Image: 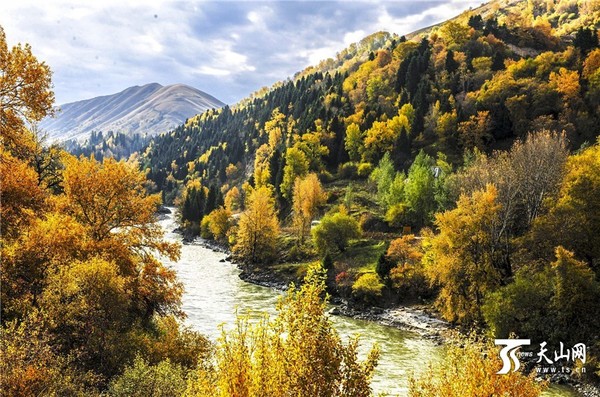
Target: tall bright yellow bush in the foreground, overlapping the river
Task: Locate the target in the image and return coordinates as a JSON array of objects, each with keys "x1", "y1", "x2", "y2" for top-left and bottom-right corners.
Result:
[{"x1": 186, "y1": 265, "x2": 379, "y2": 397}]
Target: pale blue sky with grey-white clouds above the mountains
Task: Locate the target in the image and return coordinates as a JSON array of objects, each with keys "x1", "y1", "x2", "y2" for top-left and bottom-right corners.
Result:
[{"x1": 0, "y1": 0, "x2": 481, "y2": 104}]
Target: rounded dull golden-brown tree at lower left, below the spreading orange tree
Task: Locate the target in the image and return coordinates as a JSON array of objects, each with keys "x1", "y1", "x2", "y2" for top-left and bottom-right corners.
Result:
[{"x1": 40, "y1": 258, "x2": 131, "y2": 375}]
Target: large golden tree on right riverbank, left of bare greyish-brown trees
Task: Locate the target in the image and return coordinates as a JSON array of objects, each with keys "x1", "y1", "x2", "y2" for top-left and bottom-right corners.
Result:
[{"x1": 424, "y1": 185, "x2": 502, "y2": 324}]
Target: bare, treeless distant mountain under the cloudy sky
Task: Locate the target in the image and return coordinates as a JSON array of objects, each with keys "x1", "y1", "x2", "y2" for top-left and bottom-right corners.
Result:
[{"x1": 39, "y1": 83, "x2": 224, "y2": 141}]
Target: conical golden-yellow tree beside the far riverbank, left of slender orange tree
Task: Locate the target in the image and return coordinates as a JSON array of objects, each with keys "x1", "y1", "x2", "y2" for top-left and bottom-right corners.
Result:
[{"x1": 233, "y1": 186, "x2": 279, "y2": 263}]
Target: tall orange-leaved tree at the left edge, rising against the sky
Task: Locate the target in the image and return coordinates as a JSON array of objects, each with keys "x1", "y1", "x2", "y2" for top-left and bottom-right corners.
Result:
[{"x1": 0, "y1": 26, "x2": 54, "y2": 240}]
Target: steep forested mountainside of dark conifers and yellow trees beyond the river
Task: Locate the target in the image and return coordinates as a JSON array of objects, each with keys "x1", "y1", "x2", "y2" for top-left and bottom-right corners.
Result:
[{"x1": 142, "y1": 0, "x2": 600, "y2": 212}]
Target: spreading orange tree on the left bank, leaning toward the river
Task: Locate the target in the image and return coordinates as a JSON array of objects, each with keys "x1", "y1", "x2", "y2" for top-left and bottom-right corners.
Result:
[{"x1": 59, "y1": 153, "x2": 181, "y2": 316}]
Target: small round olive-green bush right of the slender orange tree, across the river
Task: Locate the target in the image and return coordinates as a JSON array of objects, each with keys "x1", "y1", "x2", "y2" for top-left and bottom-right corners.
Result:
[{"x1": 312, "y1": 212, "x2": 361, "y2": 255}]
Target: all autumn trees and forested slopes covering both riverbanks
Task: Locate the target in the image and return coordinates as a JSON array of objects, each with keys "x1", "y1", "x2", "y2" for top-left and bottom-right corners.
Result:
[{"x1": 0, "y1": 1, "x2": 600, "y2": 396}]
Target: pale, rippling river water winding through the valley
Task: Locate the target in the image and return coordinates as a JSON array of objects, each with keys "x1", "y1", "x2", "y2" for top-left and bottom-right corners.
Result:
[{"x1": 160, "y1": 209, "x2": 576, "y2": 397}]
